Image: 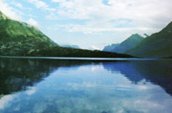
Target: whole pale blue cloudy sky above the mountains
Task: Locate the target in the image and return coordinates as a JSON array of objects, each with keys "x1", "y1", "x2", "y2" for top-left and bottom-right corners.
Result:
[{"x1": 0, "y1": 0, "x2": 172, "y2": 49}]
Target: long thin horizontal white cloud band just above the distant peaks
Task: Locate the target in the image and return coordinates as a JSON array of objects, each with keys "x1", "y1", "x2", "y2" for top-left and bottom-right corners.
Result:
[{"x1": 56, "y1": 23, "x2": 159, "y2": 35}]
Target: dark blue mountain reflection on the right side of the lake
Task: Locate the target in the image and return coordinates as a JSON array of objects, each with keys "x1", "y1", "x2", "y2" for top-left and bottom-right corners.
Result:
[{"x1": 103, "y1": 60, "x2": 172, "y2": 95}]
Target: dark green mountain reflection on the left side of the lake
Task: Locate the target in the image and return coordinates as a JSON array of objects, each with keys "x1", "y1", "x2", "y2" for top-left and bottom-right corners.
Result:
[{"x1": 0, "y1": 58, "x2": 90, "y2": 94}]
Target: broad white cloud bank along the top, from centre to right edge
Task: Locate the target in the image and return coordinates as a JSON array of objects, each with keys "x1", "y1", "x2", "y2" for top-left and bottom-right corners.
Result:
[{"x1": 53, "y1": 0, "x2": 172, "y2": 19}]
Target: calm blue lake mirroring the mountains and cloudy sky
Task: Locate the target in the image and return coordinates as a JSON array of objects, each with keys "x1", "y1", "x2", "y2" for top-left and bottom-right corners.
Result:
[{"x1": 0, "y1": 58, "x2": 172, "y2": 113}]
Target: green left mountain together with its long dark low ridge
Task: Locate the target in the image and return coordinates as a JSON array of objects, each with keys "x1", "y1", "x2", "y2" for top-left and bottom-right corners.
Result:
[{"x1": 0, "y1": 12, "x2": 130, "y2": 57}]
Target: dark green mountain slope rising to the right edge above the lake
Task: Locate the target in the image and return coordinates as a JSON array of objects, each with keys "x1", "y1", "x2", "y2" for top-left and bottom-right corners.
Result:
[{"x1": 127, "y1": 22, "x2": 172, "y2": 57}]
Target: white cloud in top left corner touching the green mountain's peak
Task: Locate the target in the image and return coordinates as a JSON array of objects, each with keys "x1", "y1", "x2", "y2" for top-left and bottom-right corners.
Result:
[{"x1": 0, "y1": 0, "x2": 21, "y2": 20}]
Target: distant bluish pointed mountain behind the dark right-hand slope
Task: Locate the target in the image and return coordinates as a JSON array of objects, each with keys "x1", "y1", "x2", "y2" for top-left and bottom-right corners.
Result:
[{"x1": 104, "y1": 34, "x2": 144, "y2": 53}]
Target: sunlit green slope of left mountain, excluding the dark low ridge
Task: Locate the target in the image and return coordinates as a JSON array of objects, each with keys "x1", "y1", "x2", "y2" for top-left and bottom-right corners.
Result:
[{"x1": 0, "y1": 12, "x2": 58, "y2": 55}]
